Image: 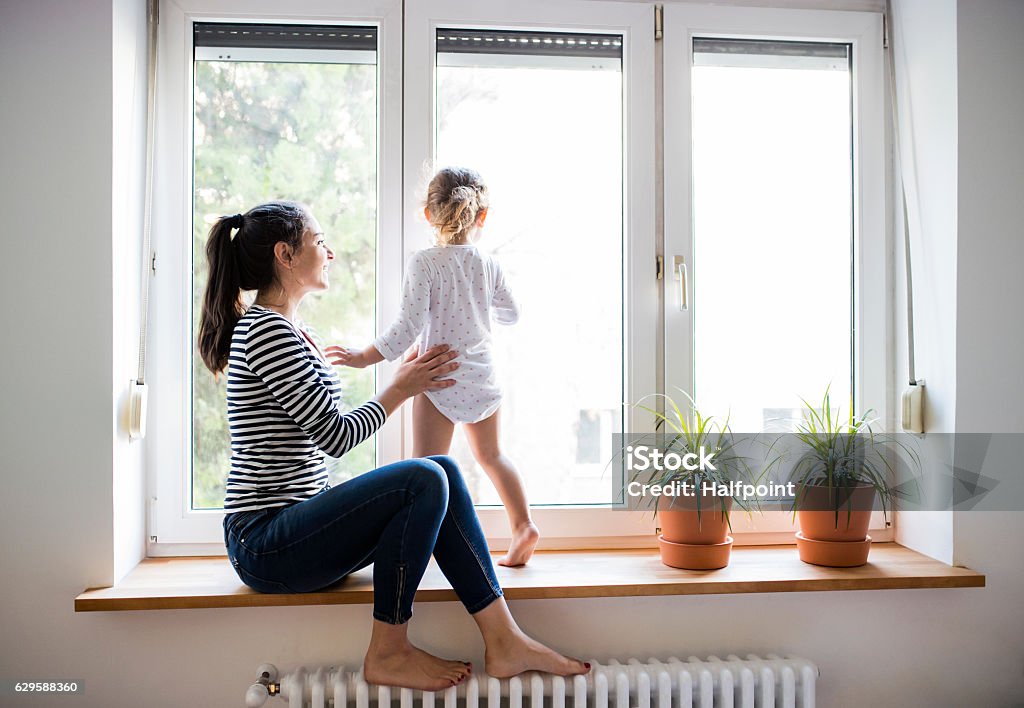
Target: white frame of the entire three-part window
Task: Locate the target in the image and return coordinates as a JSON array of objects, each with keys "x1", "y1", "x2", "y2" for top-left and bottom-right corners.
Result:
[{"x1": 145, "y1": 0, "x2": 892, "y2": 555}]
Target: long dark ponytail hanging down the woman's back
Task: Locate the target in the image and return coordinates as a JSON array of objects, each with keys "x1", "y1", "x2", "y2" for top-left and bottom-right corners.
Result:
[{"x1": 199, "y1": 214, "x2": 244, "y2": 374}]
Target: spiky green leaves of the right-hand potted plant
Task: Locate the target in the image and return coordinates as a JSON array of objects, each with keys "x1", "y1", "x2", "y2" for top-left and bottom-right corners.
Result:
[{"x1": 768, "y1": 387, "x2": 920, "y2": 523}]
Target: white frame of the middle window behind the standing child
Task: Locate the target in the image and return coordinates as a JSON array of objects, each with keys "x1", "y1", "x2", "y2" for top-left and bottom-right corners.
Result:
[{"x1": 403, "y1": 0, "x2": 658, "y2": 548}]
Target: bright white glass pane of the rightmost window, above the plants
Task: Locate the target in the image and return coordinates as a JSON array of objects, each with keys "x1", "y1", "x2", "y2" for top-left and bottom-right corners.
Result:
[{"x1": 692, "y1": 40, "x2": 853, "y2": 432}]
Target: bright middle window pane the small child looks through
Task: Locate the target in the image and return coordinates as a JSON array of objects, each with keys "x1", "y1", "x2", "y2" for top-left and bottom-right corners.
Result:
[{"x1": 434, "y1": 30, "x2": 624, "y2": 504}]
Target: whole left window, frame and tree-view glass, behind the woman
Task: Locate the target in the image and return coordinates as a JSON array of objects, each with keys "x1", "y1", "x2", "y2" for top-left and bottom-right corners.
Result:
[{"x1": 146, "y1": 0, "x2": 401, "y2": 554}]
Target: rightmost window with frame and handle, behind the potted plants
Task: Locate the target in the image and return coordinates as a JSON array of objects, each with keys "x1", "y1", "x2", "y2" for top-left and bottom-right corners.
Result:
[{"x1": 665, "y1": 6, "x2": 888, "y2": 537}]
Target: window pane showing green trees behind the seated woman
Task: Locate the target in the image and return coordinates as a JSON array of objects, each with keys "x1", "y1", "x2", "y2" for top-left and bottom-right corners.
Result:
[{"x1": 191, "y1": 43, "x2": 377, "y2": 508}]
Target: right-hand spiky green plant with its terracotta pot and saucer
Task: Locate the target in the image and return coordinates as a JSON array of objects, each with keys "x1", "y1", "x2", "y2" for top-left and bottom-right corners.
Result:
[{"x1": 769, "y1": 388, "x2": 918, "y2": 568}]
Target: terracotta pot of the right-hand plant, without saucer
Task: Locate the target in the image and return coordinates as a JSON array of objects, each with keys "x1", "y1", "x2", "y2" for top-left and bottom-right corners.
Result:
[{"x1": 797, "y1": 486, "x2": 876, "y2": 542}]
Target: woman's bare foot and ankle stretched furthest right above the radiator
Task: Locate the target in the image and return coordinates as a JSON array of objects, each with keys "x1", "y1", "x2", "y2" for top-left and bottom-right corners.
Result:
[{"x1": 472, "y1": 597, "x2": 590, "y2": 678}]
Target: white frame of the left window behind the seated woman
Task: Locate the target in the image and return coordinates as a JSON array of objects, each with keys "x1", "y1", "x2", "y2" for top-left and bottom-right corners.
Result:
[{"x1": 145, "y1": 0, "x2": 402, "y2": 556}]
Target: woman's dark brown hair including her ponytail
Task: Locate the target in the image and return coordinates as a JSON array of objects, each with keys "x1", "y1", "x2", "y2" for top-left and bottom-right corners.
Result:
[{"x1": 198, "y1": 202, "x2": 307, "y2": 374}]
